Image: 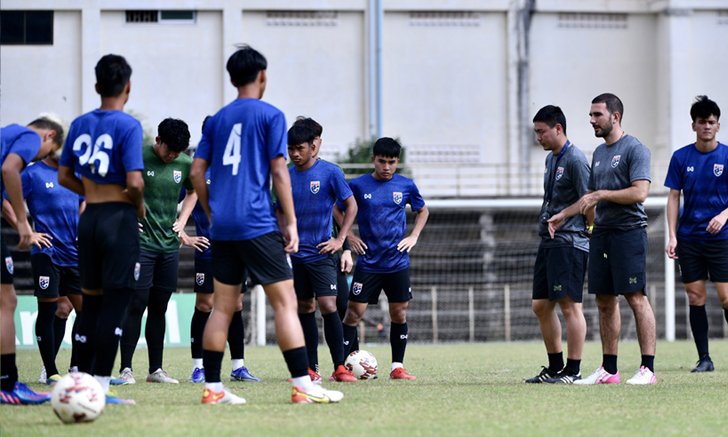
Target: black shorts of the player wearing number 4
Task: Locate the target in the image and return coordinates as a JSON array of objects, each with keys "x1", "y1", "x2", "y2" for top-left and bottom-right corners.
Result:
[{"x1": 212, "y1": 232, "x2": 293, "y2": 285}]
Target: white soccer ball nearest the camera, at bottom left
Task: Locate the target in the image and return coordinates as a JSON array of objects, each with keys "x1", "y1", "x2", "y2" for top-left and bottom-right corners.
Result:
[{"x1": 51, "y1": 372, "x2": 106, "y2": 423}]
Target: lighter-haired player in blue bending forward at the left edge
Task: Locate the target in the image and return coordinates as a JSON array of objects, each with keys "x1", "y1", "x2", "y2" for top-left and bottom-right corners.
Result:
[{"x1": 0, "y1": 119, "x2": 63, "y2": 405}]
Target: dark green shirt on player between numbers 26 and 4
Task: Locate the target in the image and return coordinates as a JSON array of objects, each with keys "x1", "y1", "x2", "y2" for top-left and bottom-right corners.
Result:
[{"x1": 139, "y1": 146, "x2": 192, "y2": 253}]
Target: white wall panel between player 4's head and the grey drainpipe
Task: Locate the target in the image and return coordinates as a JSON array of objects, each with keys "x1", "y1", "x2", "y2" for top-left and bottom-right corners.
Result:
[{"x1": 237, "y1": 11, "x2": 366, "y2": 159}]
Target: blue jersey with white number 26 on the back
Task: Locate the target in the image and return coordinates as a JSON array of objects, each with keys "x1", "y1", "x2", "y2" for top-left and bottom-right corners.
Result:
[{"x1": 61, "y1": 109, "x2": 144, "y2": 187}]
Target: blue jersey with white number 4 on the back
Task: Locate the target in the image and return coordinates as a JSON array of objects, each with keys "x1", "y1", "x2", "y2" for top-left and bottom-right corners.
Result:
[{"x1": 195, "y1": 99, "x2": 287, "y2": 241}]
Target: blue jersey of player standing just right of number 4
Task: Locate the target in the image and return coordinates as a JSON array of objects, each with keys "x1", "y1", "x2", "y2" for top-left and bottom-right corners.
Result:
[{"x1": 289, "y1": 159, "x2": 352, "y2": 263}]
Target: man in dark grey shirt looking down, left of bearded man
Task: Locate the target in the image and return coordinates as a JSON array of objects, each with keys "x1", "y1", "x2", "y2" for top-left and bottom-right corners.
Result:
[{"x1": 526, "y1": 105, "x2": 593, "y2": 384}]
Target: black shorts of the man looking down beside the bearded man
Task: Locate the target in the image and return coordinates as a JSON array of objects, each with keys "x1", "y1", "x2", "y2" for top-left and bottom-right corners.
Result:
[{"x1": 533, "y1": 246, "x2": 589, "y2": 303}]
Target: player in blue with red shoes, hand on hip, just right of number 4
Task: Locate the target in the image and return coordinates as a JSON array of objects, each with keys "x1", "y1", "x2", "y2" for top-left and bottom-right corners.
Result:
[{"x1": 288, "y1": 123, "x2": 357, "y2": 382}]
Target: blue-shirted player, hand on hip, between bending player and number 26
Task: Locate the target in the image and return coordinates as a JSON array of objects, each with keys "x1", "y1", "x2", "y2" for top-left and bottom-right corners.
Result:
[{"x1": 3, "y1": 121, "x2": 83, "y2": 384}]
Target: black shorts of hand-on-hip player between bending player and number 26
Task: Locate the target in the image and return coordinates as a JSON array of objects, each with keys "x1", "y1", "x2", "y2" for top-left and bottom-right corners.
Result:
[{"x1": 30, "y1": 253, "x2": 81, "y2": 297}]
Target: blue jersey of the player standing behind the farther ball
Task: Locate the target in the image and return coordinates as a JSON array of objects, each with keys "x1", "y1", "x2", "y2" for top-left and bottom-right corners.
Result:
[{"x1": 349, "y1": 174, "x2": 425, "y2": 273}]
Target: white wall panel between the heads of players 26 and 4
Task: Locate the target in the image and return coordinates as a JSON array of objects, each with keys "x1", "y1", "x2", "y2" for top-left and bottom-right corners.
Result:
[{"x1": 99, "y1": 11, "x2": 225, "y2": 144}]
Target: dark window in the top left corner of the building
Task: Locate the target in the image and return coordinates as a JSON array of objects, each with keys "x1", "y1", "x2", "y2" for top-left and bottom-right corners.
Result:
[{"x1": 0, "y1": 11, "x2": 53, "y2": 45}]
